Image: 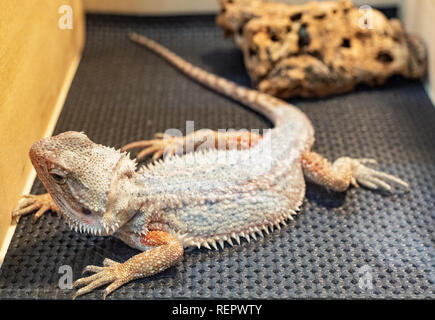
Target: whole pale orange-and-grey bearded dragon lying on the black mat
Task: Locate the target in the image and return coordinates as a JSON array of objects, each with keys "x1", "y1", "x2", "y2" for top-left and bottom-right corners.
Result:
[{"x1": 13, "y1": 34, "x2": 407, "y2": 298}]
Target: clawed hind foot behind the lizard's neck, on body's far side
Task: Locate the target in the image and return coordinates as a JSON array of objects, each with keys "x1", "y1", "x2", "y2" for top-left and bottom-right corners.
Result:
[{"x1": 121, "y1": 133, "x2": 184, "y2": 160}]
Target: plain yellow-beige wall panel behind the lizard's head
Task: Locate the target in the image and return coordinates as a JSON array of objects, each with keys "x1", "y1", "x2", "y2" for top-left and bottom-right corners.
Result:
[{"x1": 0, "y1": 0, "x2": 84, "y2": 264}]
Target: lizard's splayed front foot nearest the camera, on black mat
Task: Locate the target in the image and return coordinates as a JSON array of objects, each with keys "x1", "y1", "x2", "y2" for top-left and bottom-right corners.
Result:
[{"x1": 72, "y1": 259, "x2": 126, "y2": 299}]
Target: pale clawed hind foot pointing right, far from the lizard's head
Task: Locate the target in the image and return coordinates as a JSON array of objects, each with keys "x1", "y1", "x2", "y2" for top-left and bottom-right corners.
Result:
[{"x1": 352, "y1": 159, "x2": 409, "y2": 192}]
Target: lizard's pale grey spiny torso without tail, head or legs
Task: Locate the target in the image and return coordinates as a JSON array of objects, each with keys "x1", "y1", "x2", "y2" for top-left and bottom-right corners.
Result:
[{"x1": 137, "y1": 124, "x2": 306, "y2": 247}]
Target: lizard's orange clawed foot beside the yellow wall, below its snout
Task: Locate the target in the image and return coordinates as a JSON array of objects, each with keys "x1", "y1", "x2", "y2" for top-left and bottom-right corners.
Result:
[{"x1": 12, "y1": 193, "x2": 60, "y2": 222}]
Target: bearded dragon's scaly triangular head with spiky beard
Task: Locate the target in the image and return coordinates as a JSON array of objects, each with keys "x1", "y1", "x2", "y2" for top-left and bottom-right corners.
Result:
[{"x1": 29, "y1": 131, "x2": 136, "y2": 235}]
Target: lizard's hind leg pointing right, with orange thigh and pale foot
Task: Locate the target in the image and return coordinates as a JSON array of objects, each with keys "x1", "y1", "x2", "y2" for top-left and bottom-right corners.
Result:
[{"x1": 301, "y1": 152, "x2": 408, "y2": 192}]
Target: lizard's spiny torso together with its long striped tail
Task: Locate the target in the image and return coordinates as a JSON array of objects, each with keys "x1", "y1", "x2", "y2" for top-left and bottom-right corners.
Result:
[{"x1": 131, "y1": 34, "x2": 314, "y2": 248}]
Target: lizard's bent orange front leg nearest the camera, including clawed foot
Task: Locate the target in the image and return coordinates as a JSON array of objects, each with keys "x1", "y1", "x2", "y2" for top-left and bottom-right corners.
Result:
[{"x1": 73, "y1": 231, "x2": 183, "y2": 299}]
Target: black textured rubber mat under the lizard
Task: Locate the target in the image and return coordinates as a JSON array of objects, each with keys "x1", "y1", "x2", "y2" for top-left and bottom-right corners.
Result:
[{"x1": 0, "y1": 15, "x2": 435, "y2": 299}]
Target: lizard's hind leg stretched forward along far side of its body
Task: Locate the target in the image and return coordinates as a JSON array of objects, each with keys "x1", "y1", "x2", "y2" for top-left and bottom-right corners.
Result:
[{"x1": 121, "y1": 129, "x2": 261, "y2": 160}]
